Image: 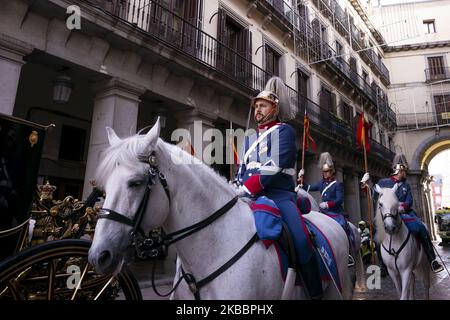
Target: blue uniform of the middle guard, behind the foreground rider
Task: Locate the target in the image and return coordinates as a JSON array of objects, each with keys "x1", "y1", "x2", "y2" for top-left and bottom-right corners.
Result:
[{"x1": 303, "y1": 177, "x2": 348, "y2": 230}]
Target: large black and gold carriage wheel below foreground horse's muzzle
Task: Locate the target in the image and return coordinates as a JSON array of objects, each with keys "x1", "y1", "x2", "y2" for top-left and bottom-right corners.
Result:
[{"x1": 0, "y1": 239, "x2": 142, "y2": 300}]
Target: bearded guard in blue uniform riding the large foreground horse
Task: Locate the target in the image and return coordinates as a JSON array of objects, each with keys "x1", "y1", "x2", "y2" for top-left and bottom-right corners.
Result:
[{"x1": 236, "y1": 77, "x2": 323, "y2": 299}]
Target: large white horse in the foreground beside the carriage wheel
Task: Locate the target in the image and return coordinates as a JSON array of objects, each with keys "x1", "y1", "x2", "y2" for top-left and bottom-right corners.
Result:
[{"x1": 89, "y1": 121, "x2": 353, "y2": 300}]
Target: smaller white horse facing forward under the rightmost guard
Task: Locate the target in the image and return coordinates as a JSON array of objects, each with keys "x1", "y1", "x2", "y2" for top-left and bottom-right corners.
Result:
[{"x1": 375, "y1": 184, "x2": 430, "y2": 300}]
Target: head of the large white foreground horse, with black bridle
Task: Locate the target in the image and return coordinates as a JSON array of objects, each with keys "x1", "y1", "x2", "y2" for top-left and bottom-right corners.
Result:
[{"x1": 89, "y1": 119, "x2": 169, "y2": 273}]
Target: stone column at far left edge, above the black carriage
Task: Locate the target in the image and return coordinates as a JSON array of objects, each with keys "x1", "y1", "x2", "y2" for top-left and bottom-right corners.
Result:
[{"x1": 0, "y1": 33, "x2": 33, "y2": 115}]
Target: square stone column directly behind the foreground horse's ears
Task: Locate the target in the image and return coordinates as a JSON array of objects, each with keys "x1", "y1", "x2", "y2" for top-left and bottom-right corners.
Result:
[{"x1": 83, "y1": 78, "x2": 145, "y2": 199}]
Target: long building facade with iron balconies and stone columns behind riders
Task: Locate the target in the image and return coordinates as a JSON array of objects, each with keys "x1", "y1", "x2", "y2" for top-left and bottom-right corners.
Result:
[{"x1": 0, "y1": 0, "x2": 396, "y2": 222}]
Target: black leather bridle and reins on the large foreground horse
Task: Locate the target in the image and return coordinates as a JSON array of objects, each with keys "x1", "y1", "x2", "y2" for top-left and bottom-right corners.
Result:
[{"x1": 98, "y1": 151, "x2": 258, "y2": 300}]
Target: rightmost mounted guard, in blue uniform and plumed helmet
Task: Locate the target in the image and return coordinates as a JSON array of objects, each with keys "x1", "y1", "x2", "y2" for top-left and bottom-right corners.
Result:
[{"x1": 361, "y1": 154, "x2": 444, "y2": 273}]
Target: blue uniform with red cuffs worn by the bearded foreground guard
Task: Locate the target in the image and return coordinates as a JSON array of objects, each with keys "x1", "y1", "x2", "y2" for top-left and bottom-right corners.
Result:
[{"x1": 236, "y1": 121, "x2": 322, "y2": 297}]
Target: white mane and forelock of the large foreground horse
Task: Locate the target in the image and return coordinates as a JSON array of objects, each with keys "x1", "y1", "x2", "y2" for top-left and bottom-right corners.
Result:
[{"x1": 95, "y1": 134, "x2": 231, "y2": 191}]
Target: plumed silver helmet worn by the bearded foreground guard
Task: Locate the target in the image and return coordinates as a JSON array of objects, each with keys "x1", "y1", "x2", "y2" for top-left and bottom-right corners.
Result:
[{"x1": 252, "y1": 77, "x2": 297, "y2": 121}]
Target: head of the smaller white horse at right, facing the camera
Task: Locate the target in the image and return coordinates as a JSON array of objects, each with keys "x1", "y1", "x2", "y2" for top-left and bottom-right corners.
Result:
[{"x1": 375, "y1": 184, "x2": 402, "y2": 235}]
